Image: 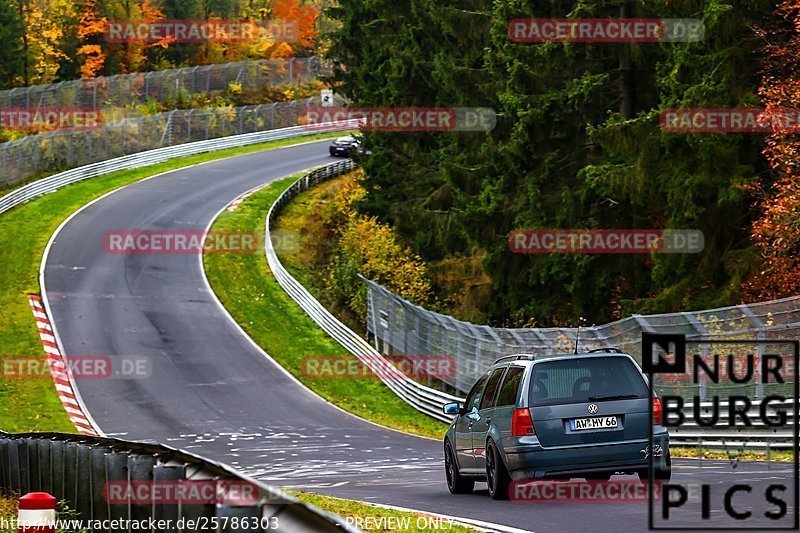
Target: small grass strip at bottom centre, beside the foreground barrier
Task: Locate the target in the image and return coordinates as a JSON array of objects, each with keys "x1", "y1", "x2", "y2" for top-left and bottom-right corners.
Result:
[{"x1": 293, "y1": 492, "x2": 482, "y2": 533}]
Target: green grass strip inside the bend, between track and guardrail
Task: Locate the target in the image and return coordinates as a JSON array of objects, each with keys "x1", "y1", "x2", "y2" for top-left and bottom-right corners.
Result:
[{"x1": 204, "y1": 175, "x2": 447, "y2": 438}]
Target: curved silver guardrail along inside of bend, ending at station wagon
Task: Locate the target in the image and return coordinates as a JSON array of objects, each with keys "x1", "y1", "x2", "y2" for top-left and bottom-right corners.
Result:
[{"x1": 264, "y1": 159, "x2": 463, "y2": 422}]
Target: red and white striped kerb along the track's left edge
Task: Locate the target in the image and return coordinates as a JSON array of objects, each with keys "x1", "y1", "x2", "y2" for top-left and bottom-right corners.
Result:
[{"x1": 28, "y1": 294, "x2": 97, "y2": 436}]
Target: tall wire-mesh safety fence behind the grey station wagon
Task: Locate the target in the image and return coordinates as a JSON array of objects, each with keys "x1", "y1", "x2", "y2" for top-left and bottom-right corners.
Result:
[{"x1": 366, "y1": 280, "x2": 800, "y2": 393}]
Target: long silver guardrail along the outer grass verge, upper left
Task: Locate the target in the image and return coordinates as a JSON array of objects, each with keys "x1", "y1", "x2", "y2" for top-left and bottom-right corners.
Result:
[{"x1": 0, "y1": 124, "x2": 349, "y2": 214}]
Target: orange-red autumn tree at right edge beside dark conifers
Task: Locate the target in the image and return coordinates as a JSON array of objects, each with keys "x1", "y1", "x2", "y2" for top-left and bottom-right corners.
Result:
[{"x1": 745, "y1": 0, "x2": 800, "y2": 300}]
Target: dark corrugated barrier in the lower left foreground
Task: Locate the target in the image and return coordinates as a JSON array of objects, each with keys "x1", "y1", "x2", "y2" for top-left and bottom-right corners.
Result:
[{"x1": 0, "y1": 432, "x2": 358, "y2": 532}]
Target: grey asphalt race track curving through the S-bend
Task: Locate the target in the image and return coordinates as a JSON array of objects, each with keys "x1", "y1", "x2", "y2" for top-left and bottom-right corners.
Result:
[{"x1": 44, "y1": 141, "x2": 792, "y2": 532}]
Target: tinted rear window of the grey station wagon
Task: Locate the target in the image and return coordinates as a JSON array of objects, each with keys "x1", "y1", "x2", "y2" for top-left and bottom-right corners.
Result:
[{"x1": 529, "y1": 356, "x2": 647, "y2": 407}]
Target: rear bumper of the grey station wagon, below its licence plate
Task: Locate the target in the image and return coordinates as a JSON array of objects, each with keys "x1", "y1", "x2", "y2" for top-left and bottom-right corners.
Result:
[{"x1": 504, "y1": 432, "x2": 669, "y2": 480}]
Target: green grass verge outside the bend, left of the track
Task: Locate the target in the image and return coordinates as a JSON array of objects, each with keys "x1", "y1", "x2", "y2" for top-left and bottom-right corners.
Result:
[{"x1": 0, "y1": 130, "x2": 339, "y2": 433}]
